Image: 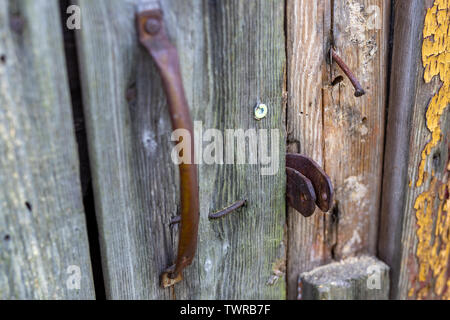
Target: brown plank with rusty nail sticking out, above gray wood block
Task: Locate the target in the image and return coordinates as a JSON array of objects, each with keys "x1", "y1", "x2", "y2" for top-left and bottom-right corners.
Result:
[{"x1": 330, "y1": 0, "x2": 390, "y2": 259}]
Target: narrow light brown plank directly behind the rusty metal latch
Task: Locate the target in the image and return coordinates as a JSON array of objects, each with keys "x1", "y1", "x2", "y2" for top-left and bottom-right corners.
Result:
[{"x1": 286, "y1": 0, "x2": 331, "y2": 299}]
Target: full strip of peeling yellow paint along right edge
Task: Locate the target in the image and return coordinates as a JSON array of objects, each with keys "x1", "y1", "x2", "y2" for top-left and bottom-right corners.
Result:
[{"x1": 408, "y1": 0, "x2": 450, "y2": 299}]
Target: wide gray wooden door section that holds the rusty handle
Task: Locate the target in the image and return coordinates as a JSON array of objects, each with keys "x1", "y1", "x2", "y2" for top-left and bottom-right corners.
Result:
[{"x1": 77, "y1": 0, "x2": 285, "y2": 299}]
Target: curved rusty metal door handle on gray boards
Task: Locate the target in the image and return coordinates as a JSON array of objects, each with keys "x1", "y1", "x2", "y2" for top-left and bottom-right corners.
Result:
[{"x1": 137, "y1": 2, "x2": 199, "y2": 288}]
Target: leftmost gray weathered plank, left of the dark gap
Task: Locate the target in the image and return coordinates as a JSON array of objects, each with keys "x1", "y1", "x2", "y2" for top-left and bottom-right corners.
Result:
[{"x1": 0, "y1": 0, "x2": 95, "y2": 299}]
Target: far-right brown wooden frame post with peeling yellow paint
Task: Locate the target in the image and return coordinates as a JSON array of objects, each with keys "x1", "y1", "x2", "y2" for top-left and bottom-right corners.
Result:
[{"x1": 379, "y1": 0, "x2": 450, "y2": 299}]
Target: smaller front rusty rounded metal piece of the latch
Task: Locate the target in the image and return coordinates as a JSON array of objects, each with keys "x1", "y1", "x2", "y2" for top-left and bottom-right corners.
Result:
[{"x1": 286, "y1": 167, "x2": 316, "y2": 217}]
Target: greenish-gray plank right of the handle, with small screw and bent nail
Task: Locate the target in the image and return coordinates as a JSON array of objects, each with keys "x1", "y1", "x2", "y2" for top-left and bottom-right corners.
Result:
[{"x1": 192, "y1": 0, "x2": 286, "y2": 299}]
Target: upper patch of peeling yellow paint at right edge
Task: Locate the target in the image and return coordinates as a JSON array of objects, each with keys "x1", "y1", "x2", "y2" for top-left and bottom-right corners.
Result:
[{"x1": 417, "y1": 0, "x2": 450, "y2": 187}]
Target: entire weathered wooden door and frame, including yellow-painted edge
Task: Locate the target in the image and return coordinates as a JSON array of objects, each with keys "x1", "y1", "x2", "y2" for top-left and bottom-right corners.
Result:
[{"x1": 0, "y1": 0, "x2": 450, "y2": 300}]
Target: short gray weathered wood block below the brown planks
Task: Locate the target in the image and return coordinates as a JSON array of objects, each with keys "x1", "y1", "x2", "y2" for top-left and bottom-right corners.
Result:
[{"x1": 299, "y1": 256, "x2": 389, "y2": 300}]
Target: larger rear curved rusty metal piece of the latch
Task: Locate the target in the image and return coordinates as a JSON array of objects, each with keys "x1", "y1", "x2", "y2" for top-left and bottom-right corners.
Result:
[{"x1": 286, "y1": 153, "x2": 333, "y2": 212}]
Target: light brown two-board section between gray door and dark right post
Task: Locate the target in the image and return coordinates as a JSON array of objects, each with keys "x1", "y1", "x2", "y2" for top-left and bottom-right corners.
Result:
[{"x1": 287, "y1": 0, "x2": 390, "y2": 299}]
